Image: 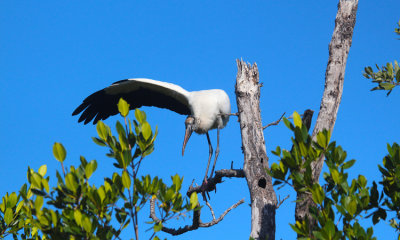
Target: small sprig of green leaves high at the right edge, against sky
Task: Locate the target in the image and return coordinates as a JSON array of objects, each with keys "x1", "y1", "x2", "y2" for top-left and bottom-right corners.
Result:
[{"x1": 363, "y1": 21, "x2": 400, "y2": 96}]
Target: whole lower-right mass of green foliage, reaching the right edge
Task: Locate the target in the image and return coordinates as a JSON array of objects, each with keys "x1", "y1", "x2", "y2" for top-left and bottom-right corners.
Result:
[{"x1": 269, "y1": 113, "x2": 400, "y2": 239}]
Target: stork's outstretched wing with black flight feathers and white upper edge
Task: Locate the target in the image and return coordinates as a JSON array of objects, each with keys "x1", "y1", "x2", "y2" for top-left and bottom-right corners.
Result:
[{"x1": 72, "y1": 78, "x2": 191, "y2": 124}]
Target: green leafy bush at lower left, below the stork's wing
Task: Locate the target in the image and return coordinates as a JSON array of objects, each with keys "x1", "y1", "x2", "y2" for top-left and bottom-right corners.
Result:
[{"x1": 0, "y1": 100, "x2": 199, "y2": 239}]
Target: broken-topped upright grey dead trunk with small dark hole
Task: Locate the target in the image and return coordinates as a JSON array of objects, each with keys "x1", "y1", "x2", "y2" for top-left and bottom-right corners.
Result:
[{"x1": 235, "y1": 60, "x2": 277, "y2": 240}]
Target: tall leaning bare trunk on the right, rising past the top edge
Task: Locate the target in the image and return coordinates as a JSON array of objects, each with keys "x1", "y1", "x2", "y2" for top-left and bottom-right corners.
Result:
[{"x1": 295, "y1": 0, "x2": 358, "y2": 230}]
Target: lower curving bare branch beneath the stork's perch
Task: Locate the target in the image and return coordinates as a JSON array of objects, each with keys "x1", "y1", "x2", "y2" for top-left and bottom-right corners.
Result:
[{"x1": 150, "y1": 198, "x2": 244, "y2": 236}]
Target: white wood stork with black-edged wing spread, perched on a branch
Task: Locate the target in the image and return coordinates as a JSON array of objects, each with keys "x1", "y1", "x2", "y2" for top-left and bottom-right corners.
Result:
[{"x1": 72, "y1": 78, "x2": 231, "y2": 184}]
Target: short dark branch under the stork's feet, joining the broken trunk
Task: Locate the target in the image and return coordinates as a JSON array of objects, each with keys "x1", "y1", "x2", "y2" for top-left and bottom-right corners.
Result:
[{"x1": 186, "y1": 169, "x2": 244, "y2": 197}]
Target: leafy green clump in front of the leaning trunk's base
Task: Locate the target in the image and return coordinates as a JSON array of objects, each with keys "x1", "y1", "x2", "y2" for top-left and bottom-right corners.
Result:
[{"x1": 269, "y1": 113, "x2": 376, "y2": 239}]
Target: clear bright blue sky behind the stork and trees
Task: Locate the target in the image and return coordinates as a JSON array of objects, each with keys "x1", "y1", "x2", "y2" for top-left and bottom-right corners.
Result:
[{"x1": 0, "y1": 0, "x2": 400, "y2": 239}]
